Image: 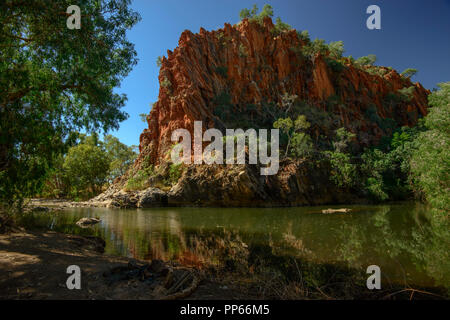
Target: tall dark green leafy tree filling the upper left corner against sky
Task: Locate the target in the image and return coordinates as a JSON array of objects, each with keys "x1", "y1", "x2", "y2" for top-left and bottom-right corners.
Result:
[{"x1": 0, "y1": 0, "x2": 140, "y2": 208}]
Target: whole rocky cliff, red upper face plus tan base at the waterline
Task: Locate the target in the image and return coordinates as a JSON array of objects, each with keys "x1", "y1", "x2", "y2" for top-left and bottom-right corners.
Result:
[{"x1": 100, "y1": 18, "x2": 429, "y2": 207}]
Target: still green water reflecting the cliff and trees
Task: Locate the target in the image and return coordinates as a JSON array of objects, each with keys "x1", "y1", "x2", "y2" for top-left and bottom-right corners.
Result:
[{"x1": 25, "y1": 203, "x2": 450, "y2": 287}]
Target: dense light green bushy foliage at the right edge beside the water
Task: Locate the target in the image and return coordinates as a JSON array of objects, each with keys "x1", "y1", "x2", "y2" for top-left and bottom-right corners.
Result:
[{"x1": 411, "y1": 82, "x2": 450, "y2": 211}]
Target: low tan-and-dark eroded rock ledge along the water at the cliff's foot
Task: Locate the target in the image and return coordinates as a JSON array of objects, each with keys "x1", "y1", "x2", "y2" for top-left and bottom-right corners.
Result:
[{"x1": 88, "y1": 160, "x2": 360, "y2": 208}]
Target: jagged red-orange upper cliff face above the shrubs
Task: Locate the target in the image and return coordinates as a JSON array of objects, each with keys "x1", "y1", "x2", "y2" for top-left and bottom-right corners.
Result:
[{"x1": 139, "y1": 18, "x2": 428, "y2": 168}]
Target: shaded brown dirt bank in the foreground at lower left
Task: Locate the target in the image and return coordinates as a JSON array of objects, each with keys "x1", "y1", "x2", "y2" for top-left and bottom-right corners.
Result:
[{"x1": 0, "y1": 231, "x2": 244, "y2": 299}]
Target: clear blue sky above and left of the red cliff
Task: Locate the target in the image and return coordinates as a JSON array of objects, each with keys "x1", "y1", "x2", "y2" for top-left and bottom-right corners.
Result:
[{"x1": 110, "y1": 0, "x2": 450, "y2": 145}]
